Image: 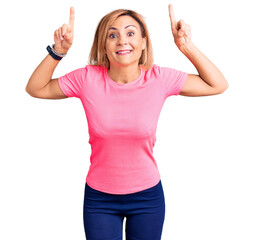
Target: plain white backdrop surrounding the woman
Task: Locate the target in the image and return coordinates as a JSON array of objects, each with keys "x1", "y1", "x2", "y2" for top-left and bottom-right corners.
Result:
[{"x1": 0, "y1": 0, "x2": 254, "y2": 240}]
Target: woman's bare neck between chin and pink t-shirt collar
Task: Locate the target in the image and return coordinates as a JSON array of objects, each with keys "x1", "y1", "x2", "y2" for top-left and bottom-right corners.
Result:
[{"x1": 108, "y1": 64, "x2": 141, "y2": 84}]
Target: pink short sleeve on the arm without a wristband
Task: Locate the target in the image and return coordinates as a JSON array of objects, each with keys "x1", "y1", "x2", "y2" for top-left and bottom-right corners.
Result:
[{"x1": 159, "y1": 67, "x2": 188, "y2": 98}]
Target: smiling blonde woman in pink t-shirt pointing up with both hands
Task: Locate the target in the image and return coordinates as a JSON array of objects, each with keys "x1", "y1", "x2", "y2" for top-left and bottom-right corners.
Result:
[{"x1": 26, "y1": 5, "x2": 228, "y2": 240}]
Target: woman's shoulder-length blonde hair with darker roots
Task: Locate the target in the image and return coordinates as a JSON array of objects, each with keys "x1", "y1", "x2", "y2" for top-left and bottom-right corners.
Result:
[{"x1": 88, "y1": 9, "x2": 153, "y2": 70}]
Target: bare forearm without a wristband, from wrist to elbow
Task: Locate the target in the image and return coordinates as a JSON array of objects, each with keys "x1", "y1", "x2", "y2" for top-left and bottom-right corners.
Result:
[{"x1": 179, "y1": 42, "x2": 228, "y2": 90}]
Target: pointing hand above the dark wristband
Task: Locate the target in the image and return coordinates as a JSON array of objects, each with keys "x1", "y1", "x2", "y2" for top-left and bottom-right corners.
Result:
[{"x1": 54, "y1": 7, "x2": 75, "y2": 54}]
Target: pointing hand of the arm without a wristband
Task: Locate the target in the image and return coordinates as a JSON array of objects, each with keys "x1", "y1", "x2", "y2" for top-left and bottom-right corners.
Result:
[{"x1": 168, "y1": 4, "x2": 191, "y2": 49}]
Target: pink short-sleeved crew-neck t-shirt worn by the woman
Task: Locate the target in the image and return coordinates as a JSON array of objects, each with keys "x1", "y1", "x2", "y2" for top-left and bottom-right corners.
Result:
[{"x1": 58, "y1": 64, "x2": 188, "y2": 194}]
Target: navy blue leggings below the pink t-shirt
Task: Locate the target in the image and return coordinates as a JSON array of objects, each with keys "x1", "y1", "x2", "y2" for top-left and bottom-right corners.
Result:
[{"x1": 83, "y1": 181, "x2": 165, "y2": 240}]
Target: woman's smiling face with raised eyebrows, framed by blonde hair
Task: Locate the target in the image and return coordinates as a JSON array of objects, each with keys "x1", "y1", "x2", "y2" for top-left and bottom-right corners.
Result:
[{"x1": 106, "y1": 16, "x2": 146, "y2": 67}]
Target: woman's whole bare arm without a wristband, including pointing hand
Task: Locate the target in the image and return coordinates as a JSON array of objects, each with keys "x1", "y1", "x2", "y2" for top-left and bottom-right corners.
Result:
[{"x1": 168, "y1": 4, "x2": 229, "y2": 96}]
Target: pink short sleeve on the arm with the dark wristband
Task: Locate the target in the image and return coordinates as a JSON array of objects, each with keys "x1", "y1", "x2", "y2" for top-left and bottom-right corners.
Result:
[{"x1": 58, "y1": 66, "x2": 87, "y2": 98}]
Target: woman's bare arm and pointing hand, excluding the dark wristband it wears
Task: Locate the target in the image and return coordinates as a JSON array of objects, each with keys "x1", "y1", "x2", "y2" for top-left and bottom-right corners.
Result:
[{"x1": 26, "y1": 7, "x2": 74, "y2": 99}]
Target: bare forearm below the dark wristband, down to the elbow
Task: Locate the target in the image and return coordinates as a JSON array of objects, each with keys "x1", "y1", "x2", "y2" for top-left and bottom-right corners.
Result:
[{"x1": 26, "y1": 54, "x2": 60, "y2": 93}]
